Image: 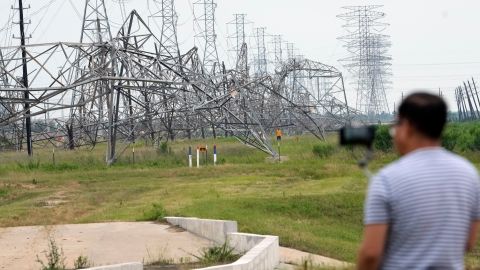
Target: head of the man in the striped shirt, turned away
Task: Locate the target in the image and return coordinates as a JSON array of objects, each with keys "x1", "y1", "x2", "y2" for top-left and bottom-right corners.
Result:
[{"x1": 394, "y1": 93, "x2": 447, "y2": 155}]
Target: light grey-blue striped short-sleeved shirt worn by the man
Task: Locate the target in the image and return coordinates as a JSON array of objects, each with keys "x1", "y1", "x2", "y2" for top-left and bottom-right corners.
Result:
[{"x1": 364, "y1": 147, "x2": 480, "y2": 269}]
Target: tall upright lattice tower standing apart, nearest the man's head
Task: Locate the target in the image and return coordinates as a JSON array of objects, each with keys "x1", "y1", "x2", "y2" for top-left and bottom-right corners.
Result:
[{"x1": 338, "y1": 6, "x2": 391, "y2": 121}]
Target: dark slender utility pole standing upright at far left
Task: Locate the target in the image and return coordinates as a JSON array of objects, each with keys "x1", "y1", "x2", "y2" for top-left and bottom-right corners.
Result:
[{"x1": 18, "y1": 0, "x2": 33, "y2": 156}]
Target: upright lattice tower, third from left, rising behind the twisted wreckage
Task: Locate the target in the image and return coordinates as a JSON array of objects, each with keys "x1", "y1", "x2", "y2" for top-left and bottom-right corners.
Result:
[{"x1": 195, "y1": 0, "x2": 219, "y2": 74}]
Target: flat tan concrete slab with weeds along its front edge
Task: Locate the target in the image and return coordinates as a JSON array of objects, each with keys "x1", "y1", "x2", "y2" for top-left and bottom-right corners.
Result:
[{"x1": 0, "y1": 222, "x2": 212, "y2": 270}]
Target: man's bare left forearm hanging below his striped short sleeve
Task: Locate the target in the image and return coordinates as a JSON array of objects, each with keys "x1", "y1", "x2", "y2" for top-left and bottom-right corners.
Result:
[{"x1": 357, "y1": 224, "x2": 388, "y2": 270}]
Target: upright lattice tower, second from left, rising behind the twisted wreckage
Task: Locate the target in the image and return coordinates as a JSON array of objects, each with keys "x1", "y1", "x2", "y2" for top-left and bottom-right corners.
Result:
[{"x1": 152, "y1": 0, "x2": 180, "y2": 59}]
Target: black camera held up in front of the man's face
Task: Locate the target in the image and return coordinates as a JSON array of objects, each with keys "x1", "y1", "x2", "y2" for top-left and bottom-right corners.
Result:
[{"x1": 340, "y1": 126, "x2": 376, "y2": 148}]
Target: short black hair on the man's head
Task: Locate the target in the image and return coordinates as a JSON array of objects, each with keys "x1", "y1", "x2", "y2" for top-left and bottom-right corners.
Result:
[{"x1": 398, "y1": 92, "x2": 447, "y2": 139}]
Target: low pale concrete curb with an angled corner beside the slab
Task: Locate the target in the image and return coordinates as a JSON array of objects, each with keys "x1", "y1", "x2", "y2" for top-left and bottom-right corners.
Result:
[{"x1": 165, "y1": 217, "x2": 280, "y2": 270}]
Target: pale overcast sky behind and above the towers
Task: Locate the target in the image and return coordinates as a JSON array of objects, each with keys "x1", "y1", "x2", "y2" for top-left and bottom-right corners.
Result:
[{"x1": 0, "y1": 0, "x2": 480, "y2": 111}]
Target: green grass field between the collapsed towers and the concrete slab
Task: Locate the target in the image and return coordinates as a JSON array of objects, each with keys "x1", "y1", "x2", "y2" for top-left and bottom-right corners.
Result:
[{"x1": 0, "y1": 136, "x2": 480, "y2": 263}]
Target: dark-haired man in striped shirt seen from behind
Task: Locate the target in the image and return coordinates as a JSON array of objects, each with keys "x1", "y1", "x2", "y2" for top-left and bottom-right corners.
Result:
[{"x1": 358, "y1": 93, "x2": 480, "y2": 269}]
